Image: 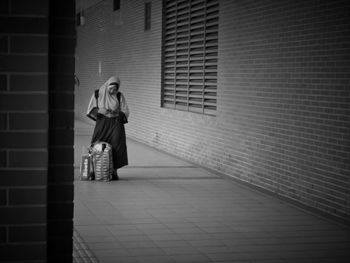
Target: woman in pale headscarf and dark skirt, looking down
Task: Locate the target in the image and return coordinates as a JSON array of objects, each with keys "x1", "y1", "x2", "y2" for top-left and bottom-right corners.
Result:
[{"x1": 87, "y1": 77, "x2": 129, "y2": 180}]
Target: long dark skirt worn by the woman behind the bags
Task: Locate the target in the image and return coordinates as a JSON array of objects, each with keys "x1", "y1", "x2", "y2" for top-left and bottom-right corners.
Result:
[{"x1": 91, "y1": 114, "x2": 128, "y2": 169}]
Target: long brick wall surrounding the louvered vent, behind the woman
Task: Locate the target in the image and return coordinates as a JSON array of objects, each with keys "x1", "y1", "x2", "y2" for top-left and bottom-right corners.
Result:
[{"x1": 75, "y1": 0, "x2": 350, "y2": 225}]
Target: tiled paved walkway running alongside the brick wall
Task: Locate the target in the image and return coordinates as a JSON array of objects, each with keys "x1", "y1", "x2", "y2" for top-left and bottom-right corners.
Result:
[{"x1": 74, "y1": 131, "x2": 350, "y2": 263}]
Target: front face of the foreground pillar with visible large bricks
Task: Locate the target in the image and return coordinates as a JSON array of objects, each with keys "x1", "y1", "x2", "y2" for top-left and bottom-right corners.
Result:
[{"x1": 0, "y1": 1, "x2": 49, "y2": 262}]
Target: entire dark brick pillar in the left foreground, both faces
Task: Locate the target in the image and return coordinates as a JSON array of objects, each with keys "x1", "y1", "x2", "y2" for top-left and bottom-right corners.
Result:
[{"x1": 0, "y1": 0, "x2": 75, "y2": 262}]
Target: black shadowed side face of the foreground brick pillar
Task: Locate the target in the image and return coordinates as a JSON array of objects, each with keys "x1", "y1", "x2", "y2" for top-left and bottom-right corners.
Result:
[{"x1": 47, "y1": 0, "x2": 76, "y2": 262}]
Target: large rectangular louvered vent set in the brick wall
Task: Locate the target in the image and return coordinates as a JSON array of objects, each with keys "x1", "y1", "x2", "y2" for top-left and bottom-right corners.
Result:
[{"x1": 162, "y1": 0, "x2": 219, "y2": 115}]
